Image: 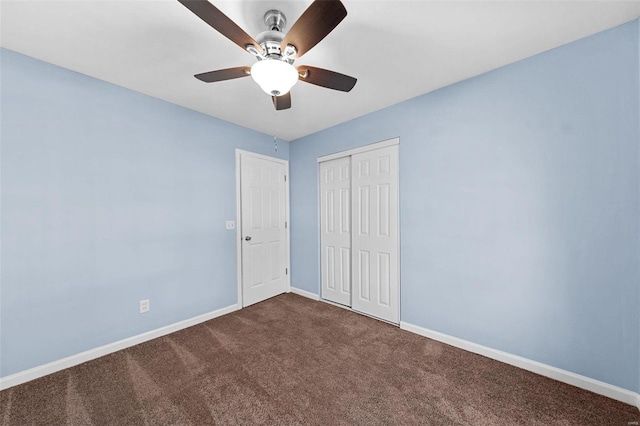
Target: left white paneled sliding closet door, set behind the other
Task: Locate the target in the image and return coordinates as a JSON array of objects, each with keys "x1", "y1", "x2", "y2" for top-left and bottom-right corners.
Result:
[{"x1": 320, "y1": 157, "x2": 351, "y2": 306}]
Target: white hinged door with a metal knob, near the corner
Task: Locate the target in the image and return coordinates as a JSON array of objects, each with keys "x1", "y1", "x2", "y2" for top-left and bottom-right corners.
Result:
[{"x1": 240, "y1": 154, "x2": 288, "y2": 306}]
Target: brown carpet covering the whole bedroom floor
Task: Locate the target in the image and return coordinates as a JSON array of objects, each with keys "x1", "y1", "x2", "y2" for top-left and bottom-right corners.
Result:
[{"x1": 0, "y1": 294, "x2": 640, "y2": 426}]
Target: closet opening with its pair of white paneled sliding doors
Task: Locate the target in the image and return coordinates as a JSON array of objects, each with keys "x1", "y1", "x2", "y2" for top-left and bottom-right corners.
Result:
[{"x1": 318, "y1": 138, "x2": 400, "y2": 324}]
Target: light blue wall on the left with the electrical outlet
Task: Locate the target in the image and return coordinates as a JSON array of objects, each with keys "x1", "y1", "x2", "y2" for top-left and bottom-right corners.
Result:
[{"x1": 0, "y1": 50, "x2": 289, "y2": 376}]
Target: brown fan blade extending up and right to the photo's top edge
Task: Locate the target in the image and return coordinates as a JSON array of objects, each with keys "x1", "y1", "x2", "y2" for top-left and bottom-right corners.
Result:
[{"x1": 280, "y1": 0, "x2": 347, "y2": 59}]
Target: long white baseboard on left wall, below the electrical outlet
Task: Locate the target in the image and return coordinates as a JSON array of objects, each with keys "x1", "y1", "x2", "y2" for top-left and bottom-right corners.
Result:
[{"x1": 0, "y1": 304, "x2": 239, "y2": 390}]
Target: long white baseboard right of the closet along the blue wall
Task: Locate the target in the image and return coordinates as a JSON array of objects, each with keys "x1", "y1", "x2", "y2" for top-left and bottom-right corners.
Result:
[{"x1": 400, "y1": 321, "x2": 640, "y2": 410}]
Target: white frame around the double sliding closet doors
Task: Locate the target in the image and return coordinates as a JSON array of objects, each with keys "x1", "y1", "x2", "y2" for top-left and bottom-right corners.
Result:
[{"x1": 316, "y1": 137, "x2": 402, "y2": 325}]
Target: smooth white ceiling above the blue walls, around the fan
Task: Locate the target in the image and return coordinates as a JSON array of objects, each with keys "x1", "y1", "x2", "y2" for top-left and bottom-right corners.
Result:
[{"x1": 0, "y1": 0, "x2": 640, "y2": 140}]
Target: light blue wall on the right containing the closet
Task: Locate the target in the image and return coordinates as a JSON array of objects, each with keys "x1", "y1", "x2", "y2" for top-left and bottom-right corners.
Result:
[{"x1": 290, "y1": 21, "x2": 640, "y2": 391}]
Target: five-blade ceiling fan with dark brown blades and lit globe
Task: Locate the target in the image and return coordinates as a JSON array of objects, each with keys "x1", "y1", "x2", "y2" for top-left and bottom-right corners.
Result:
[{"x1": 178, "y1": 0, "x2": 357, "y2": 110}]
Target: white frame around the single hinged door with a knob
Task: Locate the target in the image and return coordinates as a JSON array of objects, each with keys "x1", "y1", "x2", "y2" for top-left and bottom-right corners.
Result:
[{"x1": 236, "y1": 148, "x2": 291, "y2": 309}]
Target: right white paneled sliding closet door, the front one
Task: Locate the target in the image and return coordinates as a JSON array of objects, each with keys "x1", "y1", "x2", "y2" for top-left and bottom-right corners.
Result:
[{"x1": 351, "y1": 145, "x2": 400, "y2": 323}]
